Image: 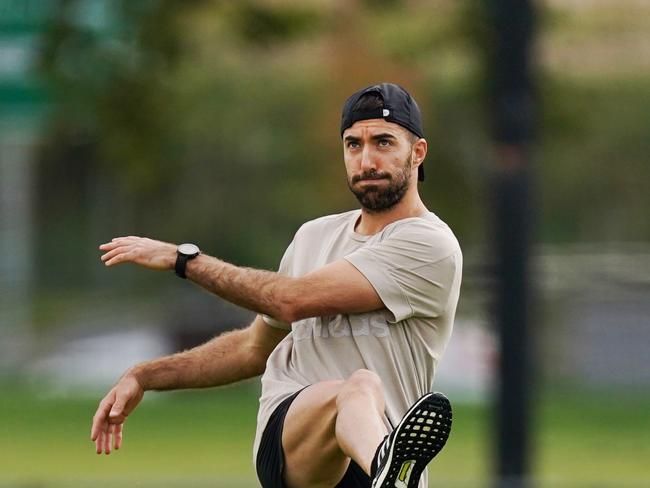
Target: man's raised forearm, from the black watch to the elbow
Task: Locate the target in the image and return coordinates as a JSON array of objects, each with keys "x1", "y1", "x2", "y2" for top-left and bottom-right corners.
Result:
[{"x1": 186, "y1": 255, "x2": 291, "y2": 322}]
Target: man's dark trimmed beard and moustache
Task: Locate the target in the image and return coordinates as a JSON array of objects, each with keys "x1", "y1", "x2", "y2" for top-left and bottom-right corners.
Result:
[{"x1": 348, "y1": 155, "x2": 411, "y2": 213}]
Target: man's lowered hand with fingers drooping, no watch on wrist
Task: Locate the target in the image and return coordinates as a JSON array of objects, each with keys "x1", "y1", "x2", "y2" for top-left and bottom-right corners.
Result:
[{"x1": 90, "y1": 373, "x2": 144, "y2": 454}]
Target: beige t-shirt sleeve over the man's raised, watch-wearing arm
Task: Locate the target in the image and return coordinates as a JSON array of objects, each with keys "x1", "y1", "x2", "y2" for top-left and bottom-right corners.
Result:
[{"x1": 345, "y1": 227, "x2": 462, "y2": 322}]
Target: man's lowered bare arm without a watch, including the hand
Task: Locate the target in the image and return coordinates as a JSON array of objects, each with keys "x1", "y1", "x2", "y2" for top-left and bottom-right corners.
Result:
[{"x1": 91, "y1": 316, "x2": 288, "y2": 454}]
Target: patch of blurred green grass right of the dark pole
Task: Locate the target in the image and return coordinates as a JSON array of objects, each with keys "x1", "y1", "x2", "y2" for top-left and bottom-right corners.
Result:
[{"x1": 537, "y1": 392, "x2": 650, "y2": 487}]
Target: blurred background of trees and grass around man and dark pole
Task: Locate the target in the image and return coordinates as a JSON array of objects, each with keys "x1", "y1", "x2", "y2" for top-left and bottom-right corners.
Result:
[{"x1": 0, "y1": 0, "x2": 650, "y2": 487}]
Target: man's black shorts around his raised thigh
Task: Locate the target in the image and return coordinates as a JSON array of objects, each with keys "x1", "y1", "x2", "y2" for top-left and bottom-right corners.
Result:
[{"x1": 256, "y1": 390, "x2": 372, "y2": 488}]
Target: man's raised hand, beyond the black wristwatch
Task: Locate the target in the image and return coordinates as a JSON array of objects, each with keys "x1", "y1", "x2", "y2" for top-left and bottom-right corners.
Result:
[{"x1": 99, "y1": 236, "x2": 177, "y2": 270}]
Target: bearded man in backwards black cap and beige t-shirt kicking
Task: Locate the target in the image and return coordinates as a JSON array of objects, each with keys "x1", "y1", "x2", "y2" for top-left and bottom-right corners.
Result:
[{"x1": 91, "y1": 83, "x2": 462, "y2": 488}]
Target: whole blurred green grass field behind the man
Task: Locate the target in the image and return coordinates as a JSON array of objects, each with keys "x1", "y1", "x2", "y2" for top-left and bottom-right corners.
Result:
[{"x1": 0, "y1": 384, "x2": 650, "y2": 488}]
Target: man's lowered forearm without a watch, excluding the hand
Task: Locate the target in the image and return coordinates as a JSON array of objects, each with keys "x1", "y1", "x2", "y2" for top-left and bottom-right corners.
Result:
[{"x1": 125, "y1": 329, "x2": 264, "y2": 390}]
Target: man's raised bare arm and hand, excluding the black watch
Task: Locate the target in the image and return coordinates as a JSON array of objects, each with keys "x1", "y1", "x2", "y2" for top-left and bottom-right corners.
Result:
[{"x1": 100, "y1": 236, "x2": 384, "y2": 324}]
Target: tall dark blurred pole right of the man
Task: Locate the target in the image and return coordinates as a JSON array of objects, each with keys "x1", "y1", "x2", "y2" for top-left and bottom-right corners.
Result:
[{"x1": 489, "y1": 0, "x2": 534, "y2": 488}]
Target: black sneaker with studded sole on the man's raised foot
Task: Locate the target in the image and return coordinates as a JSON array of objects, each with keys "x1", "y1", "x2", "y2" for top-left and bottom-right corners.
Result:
[{"x1": 372, "y1": 393, "x2": 451, "y2": 488}]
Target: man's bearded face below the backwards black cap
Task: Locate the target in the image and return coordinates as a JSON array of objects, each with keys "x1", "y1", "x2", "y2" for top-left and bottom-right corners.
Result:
[{"x1": 343, "y1": 119, "x2": 414, "y2": 213}]
